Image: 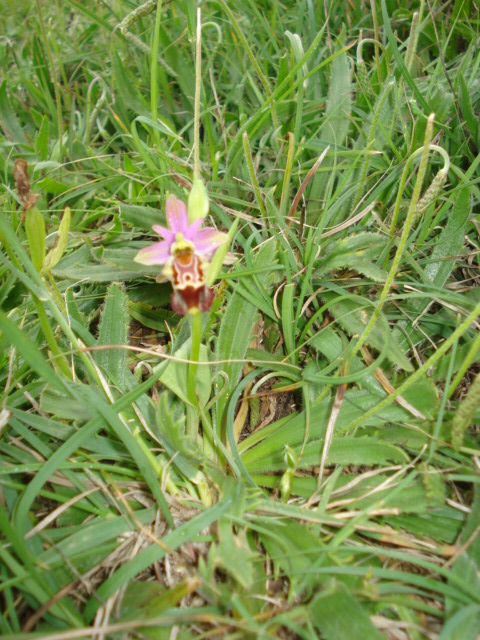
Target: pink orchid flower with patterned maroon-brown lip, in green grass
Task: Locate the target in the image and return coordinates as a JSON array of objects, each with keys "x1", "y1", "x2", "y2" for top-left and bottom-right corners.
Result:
[{"x1": 134, "y1": 195, "x2": 228, "y2": 315}]
